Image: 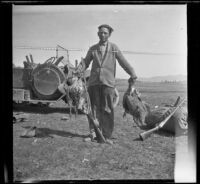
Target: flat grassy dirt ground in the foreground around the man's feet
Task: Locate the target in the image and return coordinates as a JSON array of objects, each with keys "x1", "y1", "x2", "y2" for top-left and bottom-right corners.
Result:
[{"x1": 13, "y1": 81, "x2": 187, "y2": 181}]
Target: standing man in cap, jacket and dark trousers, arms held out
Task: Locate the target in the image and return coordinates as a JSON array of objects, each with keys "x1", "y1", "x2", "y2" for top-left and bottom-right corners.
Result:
[{"x1": 77, "y1": 24, "x2": 137, "y2": 143}]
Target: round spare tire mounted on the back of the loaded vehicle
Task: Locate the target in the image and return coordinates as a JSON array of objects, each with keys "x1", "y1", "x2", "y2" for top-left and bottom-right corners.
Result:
[{"x1": 32, "y1": 63, "x2": 65, "y2": 100}]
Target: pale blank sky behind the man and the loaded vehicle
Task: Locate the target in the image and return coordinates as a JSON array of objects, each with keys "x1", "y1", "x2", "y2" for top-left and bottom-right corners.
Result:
[{"x1": 13, "y1": 5, "x2": 187, "y2": 78}]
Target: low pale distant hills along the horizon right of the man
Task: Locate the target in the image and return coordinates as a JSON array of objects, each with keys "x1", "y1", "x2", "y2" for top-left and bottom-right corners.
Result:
[{"x1": 138, "y1": 75, "x2": 187, "y2": 82}]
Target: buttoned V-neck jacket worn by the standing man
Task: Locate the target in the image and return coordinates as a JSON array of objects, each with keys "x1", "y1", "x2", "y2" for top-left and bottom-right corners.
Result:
[{"x1": 81, "y1": 42, "x2": 137, "y2": 87}]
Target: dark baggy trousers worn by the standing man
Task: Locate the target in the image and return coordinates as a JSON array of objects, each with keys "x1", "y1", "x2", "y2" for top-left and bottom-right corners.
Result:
[{"x1": 88, "y1": 85, "x2": 115, "y2": 138}]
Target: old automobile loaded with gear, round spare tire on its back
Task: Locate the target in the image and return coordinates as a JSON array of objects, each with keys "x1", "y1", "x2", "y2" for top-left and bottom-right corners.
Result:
[{"x1": 13, "y1": 46, "x2": 90, "y2": 105}]
